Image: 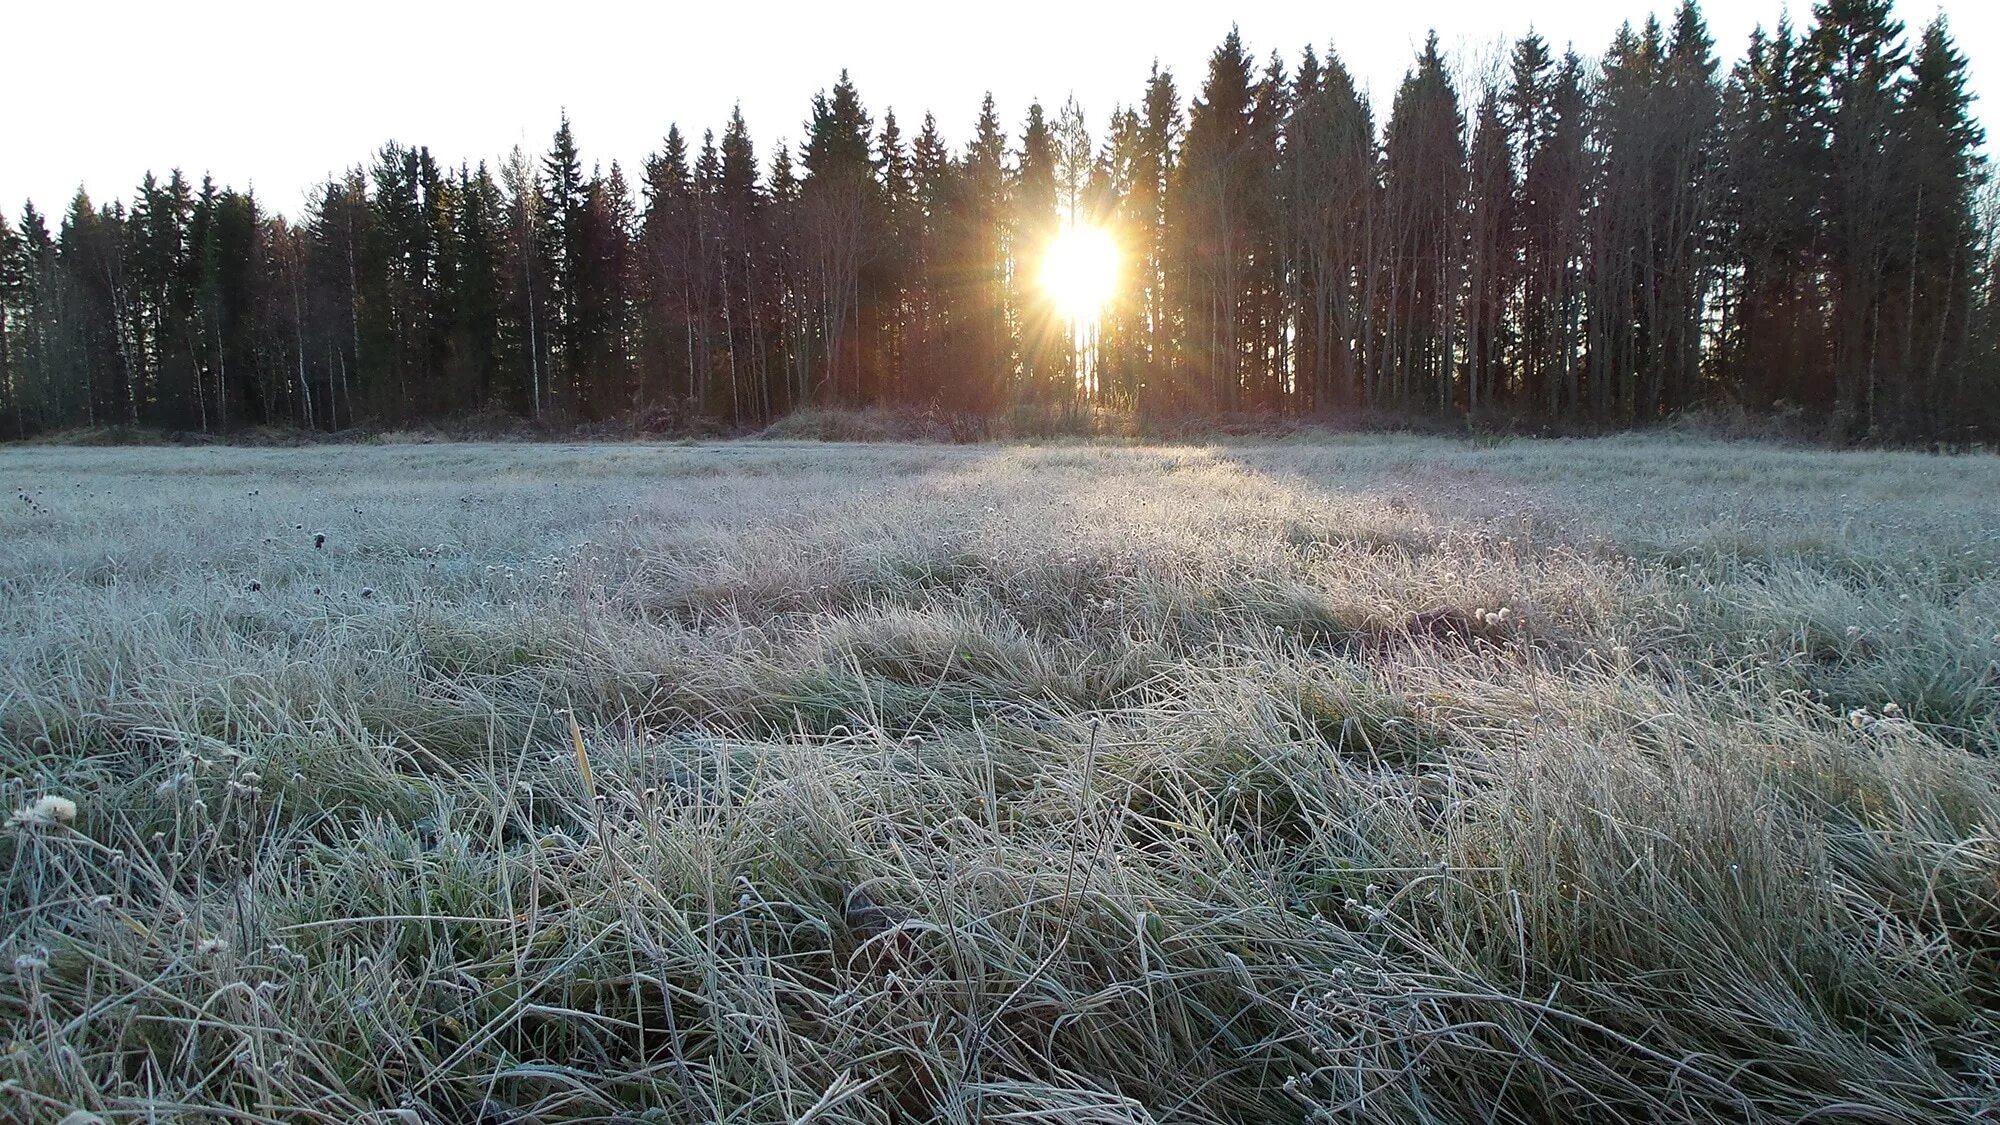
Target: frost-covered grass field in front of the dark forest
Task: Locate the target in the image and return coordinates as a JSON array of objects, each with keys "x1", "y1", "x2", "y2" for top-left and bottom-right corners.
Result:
[{"x1": 0, "y1": 436, "x2": 2000, "y2": 1125}]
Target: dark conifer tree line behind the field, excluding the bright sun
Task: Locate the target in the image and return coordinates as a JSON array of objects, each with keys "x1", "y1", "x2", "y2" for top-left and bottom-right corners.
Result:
[{"x1": 0, "y1": 0, "x2": 2000, "y2": 440}]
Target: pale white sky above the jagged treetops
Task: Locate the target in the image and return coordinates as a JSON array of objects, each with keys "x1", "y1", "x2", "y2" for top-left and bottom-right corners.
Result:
[{"x1": 0, "y1": 0, "x2": 2000, "y2": 222}]
